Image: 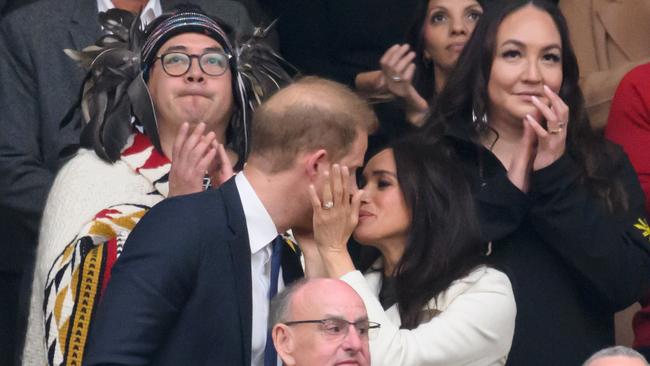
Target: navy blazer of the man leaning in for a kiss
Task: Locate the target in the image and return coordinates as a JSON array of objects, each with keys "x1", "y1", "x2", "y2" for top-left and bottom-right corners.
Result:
[{"x1": 84, "y1": 179, "x2": 252, "y2": 365}]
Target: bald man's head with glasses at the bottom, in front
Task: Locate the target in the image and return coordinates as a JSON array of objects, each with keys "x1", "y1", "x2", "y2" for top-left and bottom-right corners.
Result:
[{"x1": 269, "y1": 278, "x2": 380, "y2": 366}]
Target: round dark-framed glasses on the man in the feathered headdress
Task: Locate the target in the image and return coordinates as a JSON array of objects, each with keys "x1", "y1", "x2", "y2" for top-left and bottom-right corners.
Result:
[{"x1": 156, "y1": 52, "x2": 232, "y2": 76}]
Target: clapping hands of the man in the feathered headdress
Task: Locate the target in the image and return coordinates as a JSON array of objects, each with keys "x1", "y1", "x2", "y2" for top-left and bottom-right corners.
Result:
[{"x1": 169, "y1": 123, "x2": 233, "y2": 197}]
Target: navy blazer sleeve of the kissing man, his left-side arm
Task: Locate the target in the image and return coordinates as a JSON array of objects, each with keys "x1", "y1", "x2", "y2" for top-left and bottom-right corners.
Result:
[{"x1": 84, "y1": 197, "x2": 203, "y2": 365}]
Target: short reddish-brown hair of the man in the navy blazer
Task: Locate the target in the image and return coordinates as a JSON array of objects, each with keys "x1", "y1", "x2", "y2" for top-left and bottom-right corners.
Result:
[{"x1": 250, "y1": 77, "x2": 377, "y2": 173}]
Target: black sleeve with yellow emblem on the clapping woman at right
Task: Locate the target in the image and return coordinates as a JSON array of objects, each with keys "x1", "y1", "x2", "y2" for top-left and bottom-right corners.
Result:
[{"x1": 530, "y1": 146, "x2": 650, "y2": 311}]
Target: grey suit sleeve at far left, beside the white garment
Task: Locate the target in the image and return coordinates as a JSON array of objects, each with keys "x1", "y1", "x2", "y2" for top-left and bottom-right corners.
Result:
[{"x1": 0, "y1": 18, "x2": 54, "y2": 233}]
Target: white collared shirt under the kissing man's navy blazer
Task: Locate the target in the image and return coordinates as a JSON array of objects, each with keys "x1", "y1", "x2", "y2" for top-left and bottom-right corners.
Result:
[{"x1": 235, "y1": 172, "x2": 284, "y2": 366}]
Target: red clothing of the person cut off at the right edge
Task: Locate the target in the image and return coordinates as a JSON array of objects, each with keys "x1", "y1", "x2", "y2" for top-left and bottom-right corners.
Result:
[{"x1": 605, "y1": 64, "x2": 650, "y2": 356}]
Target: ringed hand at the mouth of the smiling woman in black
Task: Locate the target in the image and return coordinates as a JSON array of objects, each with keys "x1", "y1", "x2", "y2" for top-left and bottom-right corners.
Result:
[{"x1": 526, "y1": 85, "x2": 569, "y2": 171}]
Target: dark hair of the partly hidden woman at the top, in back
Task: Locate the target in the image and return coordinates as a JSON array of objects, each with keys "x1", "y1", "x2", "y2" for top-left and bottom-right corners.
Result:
[{"x1": 406, "y1": 0, "x2": 486, "y2": 102}]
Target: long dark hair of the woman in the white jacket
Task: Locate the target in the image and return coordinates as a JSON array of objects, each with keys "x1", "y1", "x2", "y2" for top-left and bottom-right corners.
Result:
[{"x1": 362, "y1": 136, "x2": 487, "y2": 329}]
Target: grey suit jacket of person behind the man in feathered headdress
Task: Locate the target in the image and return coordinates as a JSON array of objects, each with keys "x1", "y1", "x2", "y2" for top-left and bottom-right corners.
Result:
[{"x1": 0, "y1": 0, "x2": 252, "y2": 365}]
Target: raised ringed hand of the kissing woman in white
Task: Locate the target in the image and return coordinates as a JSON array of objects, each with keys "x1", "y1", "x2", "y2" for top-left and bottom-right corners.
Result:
[{"x1": 309, "y1": 164, "x2": 363, "y2": 255}]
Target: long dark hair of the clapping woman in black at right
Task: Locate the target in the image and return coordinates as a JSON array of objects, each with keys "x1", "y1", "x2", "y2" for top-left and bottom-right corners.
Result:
[{"x1": 424, "y1": 0, "x2": 627, "y2": 210}]
